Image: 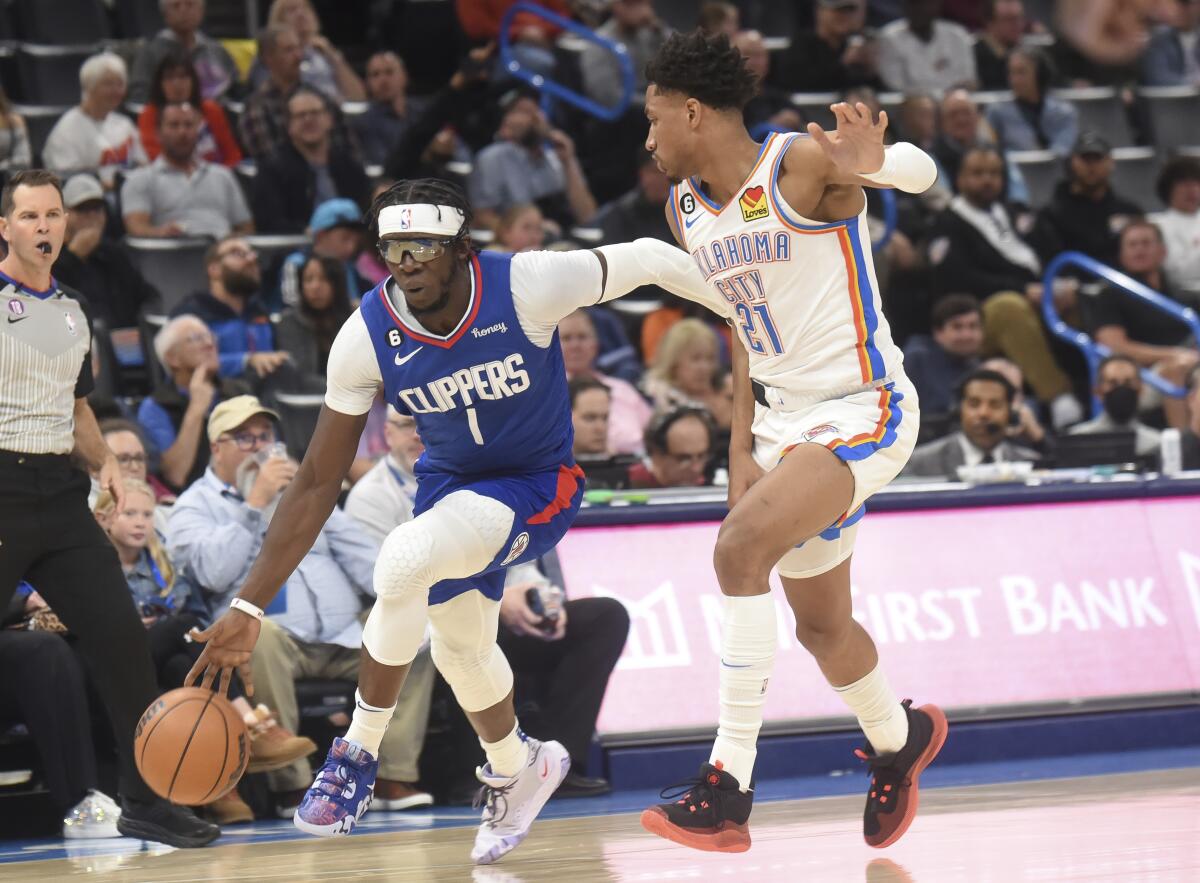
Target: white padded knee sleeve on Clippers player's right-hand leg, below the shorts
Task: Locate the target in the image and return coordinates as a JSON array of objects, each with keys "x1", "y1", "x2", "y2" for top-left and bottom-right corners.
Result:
[{"x1": 430, "y1": 591, "x2": 512, "y2": 711}]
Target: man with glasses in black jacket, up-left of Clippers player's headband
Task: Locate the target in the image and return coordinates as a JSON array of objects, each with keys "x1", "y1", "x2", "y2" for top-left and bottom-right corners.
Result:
[{"x1": 254, "y1": 86, "x2": 371, "y2": 233}]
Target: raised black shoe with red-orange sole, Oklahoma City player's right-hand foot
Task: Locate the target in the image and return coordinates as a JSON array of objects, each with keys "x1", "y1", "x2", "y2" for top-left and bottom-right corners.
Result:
[{"x1": 854, "y1": 699, "x2": 948, "y2": 848}]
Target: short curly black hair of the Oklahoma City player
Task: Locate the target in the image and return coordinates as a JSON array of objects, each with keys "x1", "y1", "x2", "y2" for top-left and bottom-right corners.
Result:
[{"x1": 646, "y1": 30, "x2": 757, "y2": 110}]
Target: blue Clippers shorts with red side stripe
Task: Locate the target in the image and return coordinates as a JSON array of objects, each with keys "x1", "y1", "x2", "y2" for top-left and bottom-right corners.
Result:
[{"x1": 413, "y1": 464, "x2": 584, "y2": 603}]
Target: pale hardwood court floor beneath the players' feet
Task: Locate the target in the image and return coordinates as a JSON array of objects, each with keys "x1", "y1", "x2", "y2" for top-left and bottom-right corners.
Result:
[{"x1": 0, "y1": 768, "x2": 1200, "y2": 883}]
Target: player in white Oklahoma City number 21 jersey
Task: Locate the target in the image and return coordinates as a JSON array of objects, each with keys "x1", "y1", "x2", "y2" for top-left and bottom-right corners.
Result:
[{"x1": 642, "y1": 32, "x2": 947, "y2": 852}]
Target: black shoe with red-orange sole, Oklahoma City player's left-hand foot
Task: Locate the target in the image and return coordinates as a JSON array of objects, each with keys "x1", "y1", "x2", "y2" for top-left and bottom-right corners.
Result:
[{"x1": 642, "y1": 763, "x2": 754, "y2": 852}]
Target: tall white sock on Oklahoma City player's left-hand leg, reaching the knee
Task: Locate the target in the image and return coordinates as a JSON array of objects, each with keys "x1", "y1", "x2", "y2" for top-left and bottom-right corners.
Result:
[{"x1": 708, "y1": 593, "x2": 779, "y2": 791}]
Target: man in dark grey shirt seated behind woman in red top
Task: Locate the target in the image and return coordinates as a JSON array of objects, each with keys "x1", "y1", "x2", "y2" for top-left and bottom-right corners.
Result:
[{"x1": 130, "y1": 0, "x2": 239, "y2": 102}]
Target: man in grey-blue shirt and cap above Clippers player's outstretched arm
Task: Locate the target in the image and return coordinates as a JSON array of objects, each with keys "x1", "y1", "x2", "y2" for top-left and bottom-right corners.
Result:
[{"x1": 470, "y1": 91, "x2": 596, "y2": 227}]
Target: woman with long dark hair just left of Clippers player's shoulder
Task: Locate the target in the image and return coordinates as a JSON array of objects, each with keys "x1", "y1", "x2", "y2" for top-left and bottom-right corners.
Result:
[{"x1": 275, "y1": 254, "x2": 354, "y2": 392}]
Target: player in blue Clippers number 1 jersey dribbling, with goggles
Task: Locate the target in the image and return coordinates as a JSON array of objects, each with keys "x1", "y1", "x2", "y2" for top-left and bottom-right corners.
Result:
[{"x1": 187, "y1": 180, "x2": 712, "y2": 864}]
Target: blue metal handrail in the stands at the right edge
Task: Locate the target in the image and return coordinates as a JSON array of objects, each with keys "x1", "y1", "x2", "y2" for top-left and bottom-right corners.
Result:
[{"x1": 1042, "y1": 252, "x2": 1200, "y2": 416}]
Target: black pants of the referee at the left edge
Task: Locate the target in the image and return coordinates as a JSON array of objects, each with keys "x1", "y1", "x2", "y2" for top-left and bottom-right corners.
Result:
[{"x1": 0, "y1": 451, "x2": 158, "y2": 800}]
